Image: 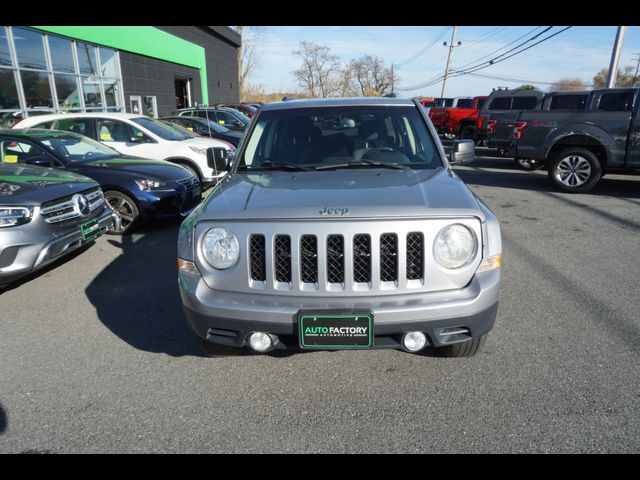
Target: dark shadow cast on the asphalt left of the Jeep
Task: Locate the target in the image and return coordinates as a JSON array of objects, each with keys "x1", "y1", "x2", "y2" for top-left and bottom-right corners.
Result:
[{"x1": 85, "y1": 221, "x2": 203, "y2": 357}]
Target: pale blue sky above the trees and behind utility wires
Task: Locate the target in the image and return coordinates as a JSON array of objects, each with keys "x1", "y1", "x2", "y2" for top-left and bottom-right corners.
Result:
[{"x1": 250, "y1": 25, "x2": 640, "y2": 97}]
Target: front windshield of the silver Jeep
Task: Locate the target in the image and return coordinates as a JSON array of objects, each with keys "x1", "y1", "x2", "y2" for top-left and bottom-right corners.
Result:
[{"x1": 237, "y1": 105, "x2": 443, "y2": 171}]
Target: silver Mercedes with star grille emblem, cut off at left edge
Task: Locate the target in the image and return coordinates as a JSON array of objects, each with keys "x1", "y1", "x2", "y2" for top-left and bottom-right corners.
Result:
[{"x1": 0, "y1": 161, "x2": 113, "y2": 288}]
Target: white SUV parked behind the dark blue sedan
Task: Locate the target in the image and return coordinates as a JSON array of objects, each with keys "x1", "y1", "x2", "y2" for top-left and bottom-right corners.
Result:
[{"x1": 12, "y1": 112, "x2": 235, "y2": 185}]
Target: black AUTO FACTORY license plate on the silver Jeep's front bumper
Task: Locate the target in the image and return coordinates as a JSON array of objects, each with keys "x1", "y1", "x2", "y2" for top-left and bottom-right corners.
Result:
[{"x1": 298, "y1": 312, "x2": 373, "y2": 349}]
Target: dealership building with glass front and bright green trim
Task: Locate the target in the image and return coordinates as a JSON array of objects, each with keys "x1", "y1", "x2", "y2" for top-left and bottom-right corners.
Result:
[{"x1": 0, "y1": 26, "x2": 241, "y2": 123}]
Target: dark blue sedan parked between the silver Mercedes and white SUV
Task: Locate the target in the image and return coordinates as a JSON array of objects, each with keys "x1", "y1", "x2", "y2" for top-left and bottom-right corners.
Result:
[{"x1": 0, "y1": 130, "x2": 202, "y2": 234}]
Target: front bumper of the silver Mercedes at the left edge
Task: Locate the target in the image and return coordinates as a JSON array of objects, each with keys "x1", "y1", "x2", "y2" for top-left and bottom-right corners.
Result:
[{"x1": 0, "y1": 208, "x2": 113, "y2": 285}]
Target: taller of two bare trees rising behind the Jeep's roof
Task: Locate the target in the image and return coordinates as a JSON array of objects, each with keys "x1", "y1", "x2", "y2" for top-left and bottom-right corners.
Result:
[{"x1": 292, "y1": 40, "x2": 341, "y2": 98}]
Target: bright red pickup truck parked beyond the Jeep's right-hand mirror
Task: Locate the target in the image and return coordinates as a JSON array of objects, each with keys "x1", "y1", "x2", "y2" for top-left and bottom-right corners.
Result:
[{"x1": 429, "y1": 96, "x2": 487, "y2": 140}]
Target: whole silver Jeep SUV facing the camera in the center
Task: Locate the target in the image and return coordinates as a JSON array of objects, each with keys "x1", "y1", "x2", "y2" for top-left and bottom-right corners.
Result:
[{"x1": 178, "y1": 98, "x2": 502, "y2": 357}]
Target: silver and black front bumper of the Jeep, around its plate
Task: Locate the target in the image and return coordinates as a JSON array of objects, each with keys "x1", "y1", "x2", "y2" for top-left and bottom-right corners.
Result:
[{"x1": 179, "y1": 269, "x2": 500, "y2": 348}]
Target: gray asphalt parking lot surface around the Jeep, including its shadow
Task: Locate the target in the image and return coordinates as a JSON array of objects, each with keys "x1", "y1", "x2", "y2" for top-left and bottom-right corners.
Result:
[{"x1": 0, "y1": 149, "x2": 640, "y2": 453}]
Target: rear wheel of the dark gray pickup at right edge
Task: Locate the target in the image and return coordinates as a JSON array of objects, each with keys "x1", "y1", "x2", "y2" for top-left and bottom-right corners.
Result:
[{"x1": 549, "y1": 147, "x2": 602, "y2": 193}]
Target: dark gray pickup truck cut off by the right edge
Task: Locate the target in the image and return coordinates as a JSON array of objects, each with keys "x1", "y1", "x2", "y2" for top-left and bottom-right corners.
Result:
[{"x1": 511, "y1": 88, "x2": 640, "y2": 193}]
